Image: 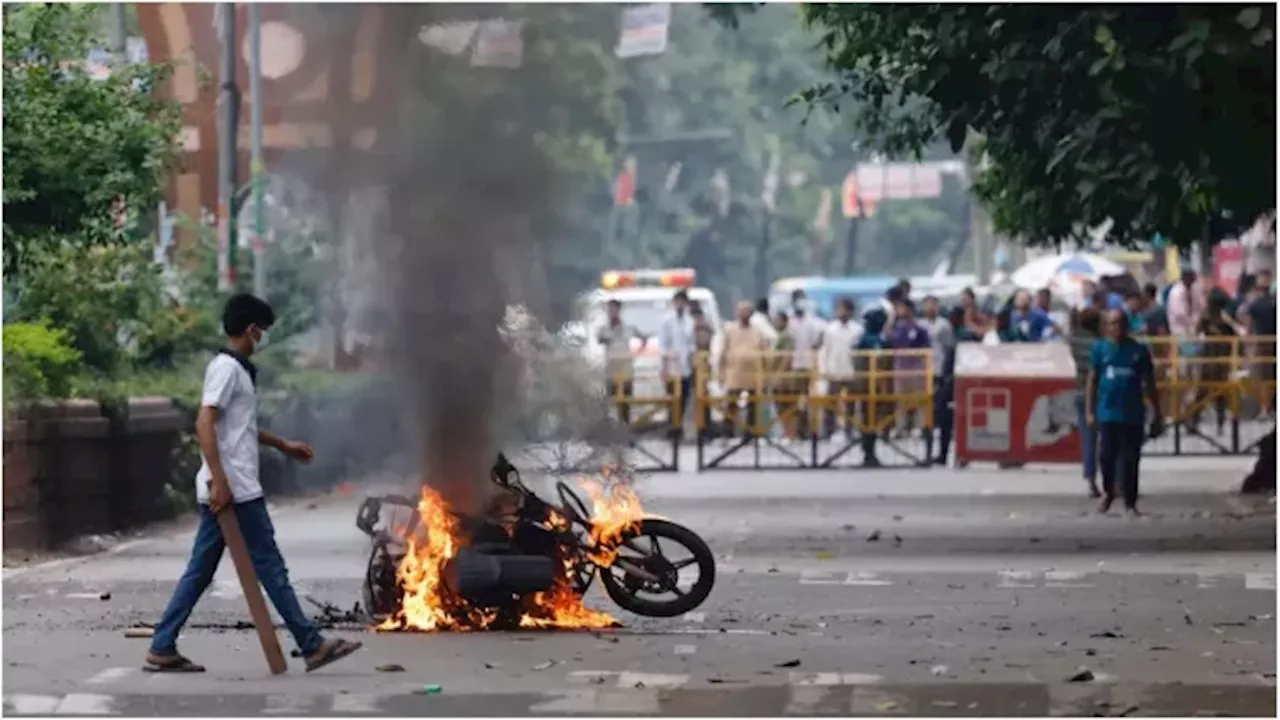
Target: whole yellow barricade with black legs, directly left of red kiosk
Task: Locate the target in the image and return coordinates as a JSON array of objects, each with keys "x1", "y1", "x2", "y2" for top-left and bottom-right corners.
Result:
[{"x1": 694, "y1": 350, "x2": 936, "y2": 470}]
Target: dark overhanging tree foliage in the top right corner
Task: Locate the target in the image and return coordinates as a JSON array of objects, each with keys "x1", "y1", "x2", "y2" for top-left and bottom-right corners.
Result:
[{"x1": 803, "y1": 4, "x2": 1276, "y2": 245}]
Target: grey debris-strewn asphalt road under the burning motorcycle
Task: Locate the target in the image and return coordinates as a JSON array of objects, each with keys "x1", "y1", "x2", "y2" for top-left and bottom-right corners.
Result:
[{"x1": 4, "y1": 460, "x2": 1276, "y2": 716}]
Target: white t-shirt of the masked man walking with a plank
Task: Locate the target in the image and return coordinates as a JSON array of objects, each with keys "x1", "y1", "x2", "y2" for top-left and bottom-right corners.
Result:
[{"x1": 196, "y1": 352, "x2": 262, "y2": 505}]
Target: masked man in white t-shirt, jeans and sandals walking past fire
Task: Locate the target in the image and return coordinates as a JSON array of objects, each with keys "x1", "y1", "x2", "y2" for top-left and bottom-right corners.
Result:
[{"x1": 145, "y1": 295, "x2": 361, "y2": 673}]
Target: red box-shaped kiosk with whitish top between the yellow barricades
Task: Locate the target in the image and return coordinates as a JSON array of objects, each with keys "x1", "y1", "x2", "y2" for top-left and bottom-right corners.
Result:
[{"x1": 955, "y1": 342, "x2": 1080, "y2": 462}]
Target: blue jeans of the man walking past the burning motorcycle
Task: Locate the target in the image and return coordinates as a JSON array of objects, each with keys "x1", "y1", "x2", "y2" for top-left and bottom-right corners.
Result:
[{"x1": 151, "y1": 498, "x2": 321, "y2": 655}]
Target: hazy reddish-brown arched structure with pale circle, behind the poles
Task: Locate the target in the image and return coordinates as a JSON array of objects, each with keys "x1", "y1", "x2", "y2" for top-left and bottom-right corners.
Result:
[{"x1": 137, "y1": 3, "x2": 403, "y2": 243}]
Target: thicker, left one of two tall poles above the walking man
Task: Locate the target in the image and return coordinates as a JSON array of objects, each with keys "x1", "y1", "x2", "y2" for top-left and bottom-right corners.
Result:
[{"x1": 218, "y1": 3, "x2": 239, "y2": 292}]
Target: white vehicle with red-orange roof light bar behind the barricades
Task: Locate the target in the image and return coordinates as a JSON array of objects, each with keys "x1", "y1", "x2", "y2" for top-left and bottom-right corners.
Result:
[{"x1": 577, "y1": 268, "x2": 724, "y2": 415}]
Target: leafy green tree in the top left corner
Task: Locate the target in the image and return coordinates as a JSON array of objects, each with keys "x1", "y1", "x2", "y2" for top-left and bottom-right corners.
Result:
[{"x1": 4, "y1": 3, "x2": 179, "y2": 279}]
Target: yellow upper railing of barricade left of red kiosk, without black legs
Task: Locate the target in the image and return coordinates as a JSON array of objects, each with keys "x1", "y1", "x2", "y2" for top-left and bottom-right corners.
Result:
[{"x1": 694, "y1": 350, "x2": 936, "y2": 437}]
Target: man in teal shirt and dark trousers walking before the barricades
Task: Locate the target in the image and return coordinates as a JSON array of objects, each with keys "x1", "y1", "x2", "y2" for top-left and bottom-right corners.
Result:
[{"x1": 1084, "y1": 304, "x2": 1164, "y2": 516}]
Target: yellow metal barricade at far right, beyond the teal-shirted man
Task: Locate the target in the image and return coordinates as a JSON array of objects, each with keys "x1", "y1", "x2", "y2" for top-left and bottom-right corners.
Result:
[{"x1": 1143, "y1": 336, "x2": 1276, "y2": 455}]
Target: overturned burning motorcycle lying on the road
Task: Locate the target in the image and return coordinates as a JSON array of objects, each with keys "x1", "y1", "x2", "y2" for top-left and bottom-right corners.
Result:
[{"x1": 356, "y1": 455, "x2": 716, "y2": 630}]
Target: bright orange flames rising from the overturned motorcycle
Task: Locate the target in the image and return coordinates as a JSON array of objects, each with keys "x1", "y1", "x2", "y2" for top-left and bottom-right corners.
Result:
[{"x1": 375, "y1": 482, "x2": 643, "y2": 632}]
